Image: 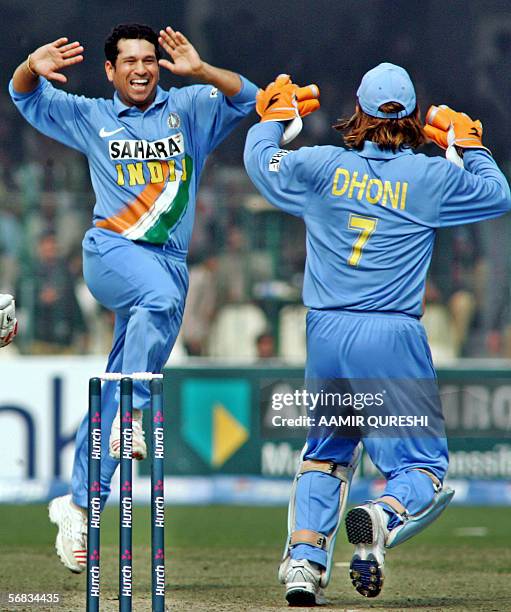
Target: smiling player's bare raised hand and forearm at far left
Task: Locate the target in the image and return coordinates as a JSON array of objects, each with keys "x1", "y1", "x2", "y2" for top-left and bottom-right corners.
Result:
[{"x1": 12, "y1": 38, "x2": 83, "y2": 93}]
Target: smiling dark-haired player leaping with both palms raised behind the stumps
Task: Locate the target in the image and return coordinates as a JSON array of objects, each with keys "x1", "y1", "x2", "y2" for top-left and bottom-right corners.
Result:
[{"x1": 9, "y1": 24, "x2": 257, "y2": 572}]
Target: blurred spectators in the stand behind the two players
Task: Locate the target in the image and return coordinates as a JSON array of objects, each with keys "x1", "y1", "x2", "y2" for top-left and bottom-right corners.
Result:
[{"x1": 0, "y1": 109, "x2": 511, "y2": 363}]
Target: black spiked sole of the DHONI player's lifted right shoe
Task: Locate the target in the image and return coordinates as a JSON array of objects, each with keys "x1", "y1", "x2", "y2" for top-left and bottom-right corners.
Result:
[{"x1": 346, "y1": 508, "x2": 384, "y2": 597}]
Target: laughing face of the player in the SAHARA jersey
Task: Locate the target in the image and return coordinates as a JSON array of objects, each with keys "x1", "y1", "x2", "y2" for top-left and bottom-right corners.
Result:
[{"x1": 105, "y1": 38, "x2": 160, "y2": 111}]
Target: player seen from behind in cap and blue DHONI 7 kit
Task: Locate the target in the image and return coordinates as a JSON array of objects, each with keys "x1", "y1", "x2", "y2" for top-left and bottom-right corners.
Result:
[{"x1": 245, "y1": 69, "x2": 511, "y2": 605}]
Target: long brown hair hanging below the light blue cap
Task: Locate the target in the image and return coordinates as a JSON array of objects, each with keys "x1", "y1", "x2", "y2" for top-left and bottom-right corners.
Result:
[{"x1": 332, "y1": 102, "x2": 427, "y2": 153}]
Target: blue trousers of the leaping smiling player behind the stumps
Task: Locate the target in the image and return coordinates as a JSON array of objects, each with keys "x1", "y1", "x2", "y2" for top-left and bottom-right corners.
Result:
[{"x1": 71, "y1": 228, "x2": 188, "y2": 507}]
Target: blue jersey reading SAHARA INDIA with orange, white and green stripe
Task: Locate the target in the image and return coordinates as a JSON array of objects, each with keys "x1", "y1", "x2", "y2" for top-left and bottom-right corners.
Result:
[{"x1": 9, "y1": 77, "x2": 257, "y2": 246}]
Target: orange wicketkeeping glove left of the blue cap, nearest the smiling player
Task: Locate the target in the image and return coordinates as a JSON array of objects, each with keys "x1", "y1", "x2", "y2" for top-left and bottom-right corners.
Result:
[{"x1": 256, "y1": 74, "x2": 320, "y2": 145}]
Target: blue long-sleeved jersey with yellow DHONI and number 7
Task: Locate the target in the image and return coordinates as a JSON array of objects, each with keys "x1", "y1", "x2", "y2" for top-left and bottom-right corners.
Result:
[{"x1": 245, "y1": 122, "x2": 511, "y2": 316}]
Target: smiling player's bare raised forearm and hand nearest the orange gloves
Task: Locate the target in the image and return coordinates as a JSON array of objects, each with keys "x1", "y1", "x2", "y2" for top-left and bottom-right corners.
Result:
[{"x1": 158, "y1": 26, "x2": 241, "y2": 96}]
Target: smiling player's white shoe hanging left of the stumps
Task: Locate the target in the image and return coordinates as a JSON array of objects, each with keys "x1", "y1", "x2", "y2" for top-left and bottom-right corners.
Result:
[{"x1": 48, "y1": 495, "x2": 87, "y2": 574}]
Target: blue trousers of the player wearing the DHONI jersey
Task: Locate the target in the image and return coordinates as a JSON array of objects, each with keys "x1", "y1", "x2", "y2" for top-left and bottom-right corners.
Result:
[{"x1": 291, "y1": 310, "x2": 448, "y2": 566}]
